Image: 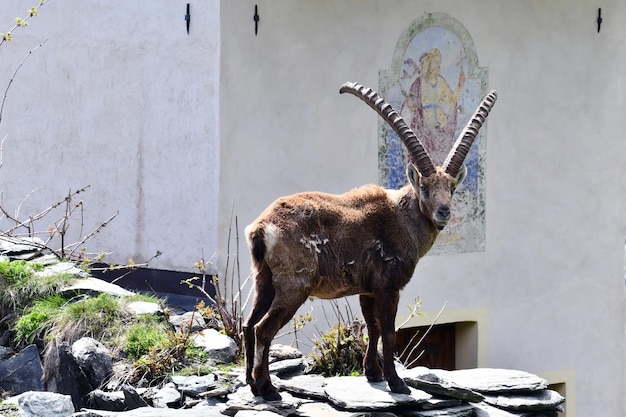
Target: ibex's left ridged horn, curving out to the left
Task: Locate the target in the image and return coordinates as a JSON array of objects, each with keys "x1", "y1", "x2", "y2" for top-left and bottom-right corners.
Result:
[{"x1": 339, "y1": 82, "x2": 435, "y2": 177}]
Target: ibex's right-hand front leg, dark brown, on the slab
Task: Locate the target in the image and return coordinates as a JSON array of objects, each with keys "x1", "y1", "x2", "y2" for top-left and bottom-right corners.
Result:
[{"x1": 374, "y1": 289, "x2": 411, "y2": 394}]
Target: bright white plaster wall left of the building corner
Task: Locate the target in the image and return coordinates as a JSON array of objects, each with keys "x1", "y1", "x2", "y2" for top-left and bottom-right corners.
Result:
[{"x1": 0, "y1": 0, "x2": 220, "y2": 271}]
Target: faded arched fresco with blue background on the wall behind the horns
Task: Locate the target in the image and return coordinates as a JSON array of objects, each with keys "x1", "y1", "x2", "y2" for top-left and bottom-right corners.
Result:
[{"x1": 378, "y1": 13, "x2": 487, "y2": 254}]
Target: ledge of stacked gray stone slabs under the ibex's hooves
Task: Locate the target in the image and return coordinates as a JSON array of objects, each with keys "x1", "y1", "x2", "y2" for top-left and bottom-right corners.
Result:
[{"x1": 2, "y1": 343, "x2": 565, "y2": 417}]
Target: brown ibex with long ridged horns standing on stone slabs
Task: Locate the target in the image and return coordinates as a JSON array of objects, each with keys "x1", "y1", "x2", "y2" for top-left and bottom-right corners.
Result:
[{"x1": 244, "y1": 83, "x2": 497, "y2": 401}]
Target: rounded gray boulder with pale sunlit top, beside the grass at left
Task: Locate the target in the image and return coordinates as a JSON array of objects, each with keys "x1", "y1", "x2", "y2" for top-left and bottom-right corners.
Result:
[{"x1": 72, "y1": 337, "x2": 113, "y2": 388}]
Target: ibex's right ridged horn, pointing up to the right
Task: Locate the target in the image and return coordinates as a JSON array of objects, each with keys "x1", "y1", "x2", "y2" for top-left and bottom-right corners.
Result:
[{"x1": 442, "y1": 90, "x2": 498, "y2": 177}]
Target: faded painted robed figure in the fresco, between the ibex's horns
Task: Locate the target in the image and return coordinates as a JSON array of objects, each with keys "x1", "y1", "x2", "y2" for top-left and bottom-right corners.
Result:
[{"x1": 401, "y1": 48, "x2": 465, "y2": 164}]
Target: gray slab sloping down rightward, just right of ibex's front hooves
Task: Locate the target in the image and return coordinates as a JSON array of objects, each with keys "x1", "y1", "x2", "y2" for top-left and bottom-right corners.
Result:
[{"x1": 398, "y1": 366, "x2": 484, "y2": 402}]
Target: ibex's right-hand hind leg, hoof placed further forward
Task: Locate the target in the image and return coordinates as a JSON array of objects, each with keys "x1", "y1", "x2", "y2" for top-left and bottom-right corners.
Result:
[{"x1": 252, "y1": 278, "x2": 309, "y2": 401}]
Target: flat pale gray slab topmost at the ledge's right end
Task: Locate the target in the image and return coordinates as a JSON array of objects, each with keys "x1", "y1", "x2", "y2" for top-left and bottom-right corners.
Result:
[{"x1": 447, "y1": 368, "x2": 548, "y2": 393}]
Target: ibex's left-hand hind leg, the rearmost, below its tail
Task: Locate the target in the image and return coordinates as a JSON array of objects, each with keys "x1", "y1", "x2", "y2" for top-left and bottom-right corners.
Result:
[{"x1": 243, "y1": 265, "x2": 274, "y2": 395}]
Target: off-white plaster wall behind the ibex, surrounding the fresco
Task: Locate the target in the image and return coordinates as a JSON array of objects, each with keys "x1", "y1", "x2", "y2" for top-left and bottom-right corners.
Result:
[{"x1": 218, "y1": 0, "x2": 626, "y2": 416}]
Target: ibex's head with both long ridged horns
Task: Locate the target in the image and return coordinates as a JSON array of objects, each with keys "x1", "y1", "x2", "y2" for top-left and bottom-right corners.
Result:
[{"x1": 339, "y1": 83, "x2": 497, "y2": 230}]
